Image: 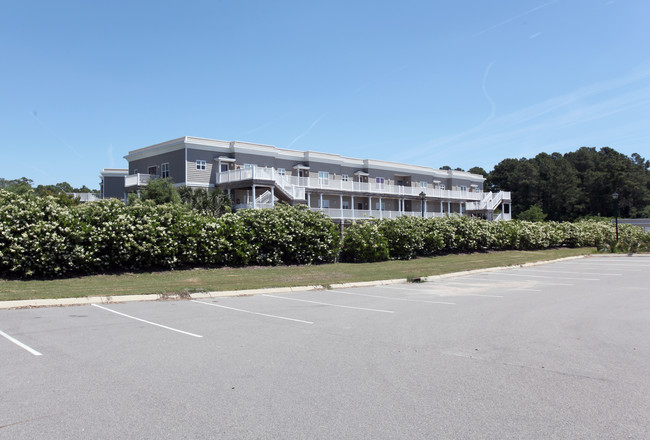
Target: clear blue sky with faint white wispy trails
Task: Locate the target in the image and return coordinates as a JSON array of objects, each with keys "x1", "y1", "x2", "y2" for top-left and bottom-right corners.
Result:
[{"x1": 0, "y1": 0, "x2": 650, "y2": 188}]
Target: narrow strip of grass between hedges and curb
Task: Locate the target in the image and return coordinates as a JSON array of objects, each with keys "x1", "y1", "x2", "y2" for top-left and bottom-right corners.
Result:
[{"x1": 0, "y1": 248, "x2": 595, "y2": 301}]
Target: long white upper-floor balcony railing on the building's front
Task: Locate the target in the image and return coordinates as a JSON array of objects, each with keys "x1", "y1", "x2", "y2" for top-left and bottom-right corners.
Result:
[{"x1": 217, "y1": 168, "x2": 484, "y2": 201}]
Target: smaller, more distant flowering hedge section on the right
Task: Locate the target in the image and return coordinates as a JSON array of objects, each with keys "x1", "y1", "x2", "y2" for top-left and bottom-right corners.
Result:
[{"x1": 341, "y1": 216, "x2": 650, "y2": 262}]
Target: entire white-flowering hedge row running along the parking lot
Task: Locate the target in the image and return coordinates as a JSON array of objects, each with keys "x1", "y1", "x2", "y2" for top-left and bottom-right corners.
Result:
[{"x1": 0, "y1": 190, "x2": 650, "y2": 278}]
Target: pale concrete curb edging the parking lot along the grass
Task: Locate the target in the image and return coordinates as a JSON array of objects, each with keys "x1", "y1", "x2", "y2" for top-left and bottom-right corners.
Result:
[{"x1": 0, "y1": 254, "x2": 592, "y2": 310}]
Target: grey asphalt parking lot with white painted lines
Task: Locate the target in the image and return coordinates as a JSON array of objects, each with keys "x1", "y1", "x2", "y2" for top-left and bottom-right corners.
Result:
[{"x1": 0, "y1": 256, "x2": 650, "y2": 439}]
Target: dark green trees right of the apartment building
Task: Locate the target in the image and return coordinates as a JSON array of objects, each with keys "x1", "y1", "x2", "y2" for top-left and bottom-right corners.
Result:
[{"x1": 489, "y1": 147, "x2": 650, "y2": 221}]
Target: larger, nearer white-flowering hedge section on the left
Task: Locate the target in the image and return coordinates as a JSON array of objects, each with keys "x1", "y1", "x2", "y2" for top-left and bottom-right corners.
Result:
[{"x1": 0, "y1": 190, "x2": 340, "y2": 278}]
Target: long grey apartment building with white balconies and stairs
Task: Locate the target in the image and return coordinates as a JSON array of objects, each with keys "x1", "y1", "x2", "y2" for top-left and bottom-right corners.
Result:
[{"x1": 102, "y1": 137, "x2": 511, "y2": 222}]
